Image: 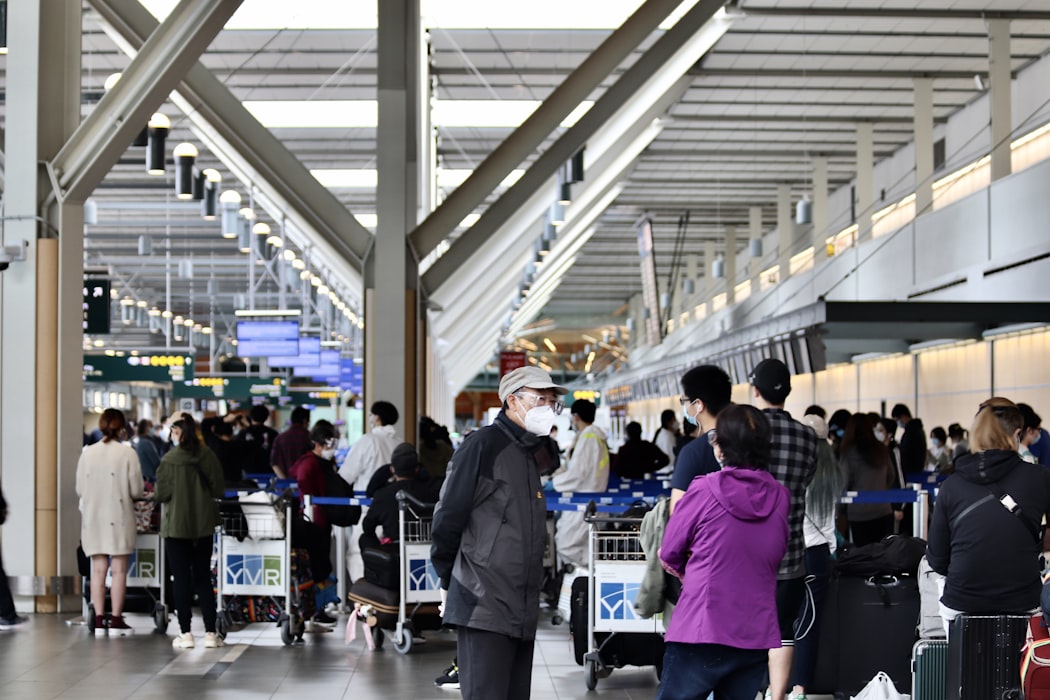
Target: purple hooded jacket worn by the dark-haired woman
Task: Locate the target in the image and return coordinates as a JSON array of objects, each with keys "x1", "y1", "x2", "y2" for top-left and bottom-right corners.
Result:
[{"x1": 659, "y1": 467, "x2": 791, "y2": 649}]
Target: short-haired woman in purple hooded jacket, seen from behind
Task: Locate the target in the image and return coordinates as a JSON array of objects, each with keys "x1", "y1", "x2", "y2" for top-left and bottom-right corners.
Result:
[{"x1": 656, "y1": 405, "x2": 791, "y2": 700}]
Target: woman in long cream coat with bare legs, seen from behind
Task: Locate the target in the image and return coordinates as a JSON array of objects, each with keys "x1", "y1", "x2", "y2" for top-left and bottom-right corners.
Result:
[{"x1": 77, "y1": 408, "x2": 144, "y2": 636}]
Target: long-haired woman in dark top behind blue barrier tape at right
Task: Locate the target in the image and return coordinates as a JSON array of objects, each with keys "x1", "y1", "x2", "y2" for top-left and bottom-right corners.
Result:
[{"x1": 839, "y1": 413, "x2": 894, "y2": 545}]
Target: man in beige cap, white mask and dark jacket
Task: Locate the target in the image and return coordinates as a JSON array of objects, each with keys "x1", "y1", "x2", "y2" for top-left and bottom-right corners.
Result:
[{"x1": 431, "y1": 366, "x2": 568, "y2": 700}]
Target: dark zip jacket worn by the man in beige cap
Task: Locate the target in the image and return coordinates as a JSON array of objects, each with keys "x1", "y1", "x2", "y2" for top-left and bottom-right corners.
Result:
[{"x1": 431, "y1": 412, "x2": 558, "y2": 640}]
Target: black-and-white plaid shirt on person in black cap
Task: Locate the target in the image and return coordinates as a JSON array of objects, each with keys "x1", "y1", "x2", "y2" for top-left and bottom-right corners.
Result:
[{"x1": 762, "y1": 408, "x2": 817, "y2": 580}]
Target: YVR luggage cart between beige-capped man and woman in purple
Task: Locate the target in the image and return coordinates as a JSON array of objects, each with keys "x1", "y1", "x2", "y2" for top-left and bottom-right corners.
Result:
[{"x1": 583, "y1": 504, "x2": 664, "y2": 691}]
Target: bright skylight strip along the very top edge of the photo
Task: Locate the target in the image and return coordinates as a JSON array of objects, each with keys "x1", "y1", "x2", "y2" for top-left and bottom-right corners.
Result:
[{"x1": 142, "y1": 0, "x2": 696, "y2": 30}]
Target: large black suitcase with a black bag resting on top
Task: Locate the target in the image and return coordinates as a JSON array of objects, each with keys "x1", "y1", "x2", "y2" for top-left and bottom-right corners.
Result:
[{"x1": 806, "y1": 576, "x2": 919, "y2": 697}]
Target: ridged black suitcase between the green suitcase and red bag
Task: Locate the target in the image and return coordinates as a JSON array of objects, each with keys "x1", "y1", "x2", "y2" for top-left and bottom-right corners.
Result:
[{"x1": 945, "y1": 615, "x2": 1030, "y2": 700}]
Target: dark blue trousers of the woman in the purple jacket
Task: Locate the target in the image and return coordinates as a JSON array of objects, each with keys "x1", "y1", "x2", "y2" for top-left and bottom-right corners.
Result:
[{"x1": 656, "y1": 641, "x2": 769, "y2": 700}]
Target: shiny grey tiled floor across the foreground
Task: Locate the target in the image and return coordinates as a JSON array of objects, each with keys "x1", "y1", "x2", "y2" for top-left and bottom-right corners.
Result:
[{"x1": 0, "y1": 615, "x2": 656, "y2": 700}]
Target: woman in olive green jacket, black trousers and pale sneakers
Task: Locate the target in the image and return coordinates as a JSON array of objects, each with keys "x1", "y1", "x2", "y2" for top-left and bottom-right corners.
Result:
[{"x1": 154, "y1": 413, "x2": 224, "y2": 649}]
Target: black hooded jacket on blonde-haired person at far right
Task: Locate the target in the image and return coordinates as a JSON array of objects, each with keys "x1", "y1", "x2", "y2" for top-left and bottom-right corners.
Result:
[{"x1": 926, "y1": 450, "x2": 1050, "y2": 613}]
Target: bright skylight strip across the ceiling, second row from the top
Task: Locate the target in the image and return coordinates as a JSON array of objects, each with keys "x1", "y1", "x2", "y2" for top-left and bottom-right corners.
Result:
[{"x1": 244, "y1": 100, "x2": 594, "y2": 129}]
